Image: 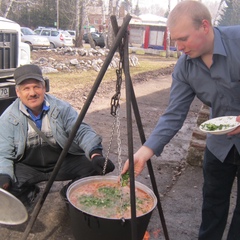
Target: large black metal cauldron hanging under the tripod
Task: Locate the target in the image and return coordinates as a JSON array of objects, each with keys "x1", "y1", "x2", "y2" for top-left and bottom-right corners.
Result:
[{"x1": 67, "y1": 176, "x2": 157, "y2": 240}]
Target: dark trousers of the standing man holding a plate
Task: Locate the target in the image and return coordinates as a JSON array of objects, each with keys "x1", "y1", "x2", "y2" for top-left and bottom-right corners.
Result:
[{"x1": 198, "y1": 146, "x2": 240, "y2": 240}]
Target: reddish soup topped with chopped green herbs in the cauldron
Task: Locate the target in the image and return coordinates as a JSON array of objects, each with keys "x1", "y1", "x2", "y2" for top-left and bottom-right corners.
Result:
[{"x1": 69, "y1": 180, "x2": 154, "y2": 219}]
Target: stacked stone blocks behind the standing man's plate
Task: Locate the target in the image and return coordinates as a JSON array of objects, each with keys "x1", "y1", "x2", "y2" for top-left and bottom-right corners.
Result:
[{"x1": 186, "y1": 105, "x2": 209, "y2": 166}]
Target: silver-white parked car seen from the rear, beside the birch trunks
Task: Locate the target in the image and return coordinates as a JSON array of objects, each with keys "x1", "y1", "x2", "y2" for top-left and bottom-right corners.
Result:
[{"x1": 34, "y1": 28, "x2": 74, "y2": 48}]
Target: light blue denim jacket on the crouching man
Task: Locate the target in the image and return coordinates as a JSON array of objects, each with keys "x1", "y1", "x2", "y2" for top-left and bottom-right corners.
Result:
[{"x1": 0, "y1": 94, "x2": 102, "y2": 180}]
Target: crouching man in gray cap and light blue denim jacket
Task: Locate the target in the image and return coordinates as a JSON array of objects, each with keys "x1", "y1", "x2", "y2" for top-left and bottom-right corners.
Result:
[{"x1": 0, "y1": 64, "x2": 114, "y2": 205}]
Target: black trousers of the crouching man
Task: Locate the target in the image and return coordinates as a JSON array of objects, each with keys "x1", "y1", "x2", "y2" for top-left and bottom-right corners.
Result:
[{"x1": 10, "y1": 154, "x2": 97, "y2": 192}]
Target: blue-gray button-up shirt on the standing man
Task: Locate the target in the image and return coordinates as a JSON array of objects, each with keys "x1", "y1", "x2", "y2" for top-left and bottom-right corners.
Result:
[{"x1": 144, "y1": 26, "x2": 240, "y2": 161}]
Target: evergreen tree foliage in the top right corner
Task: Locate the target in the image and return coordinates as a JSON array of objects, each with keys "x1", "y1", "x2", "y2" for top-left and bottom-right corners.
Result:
[{"x1": 218, "y1": 0, "x2": 240, "y2": 26}]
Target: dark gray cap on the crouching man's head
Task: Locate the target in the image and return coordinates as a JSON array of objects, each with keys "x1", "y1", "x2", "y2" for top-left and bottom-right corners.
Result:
[{"x1": 14, "y1": 64, "x2": 44, "y2": 85}]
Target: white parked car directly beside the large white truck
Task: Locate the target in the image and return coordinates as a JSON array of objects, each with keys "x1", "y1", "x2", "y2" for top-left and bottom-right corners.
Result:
[{"x1": 21, "y1": 27, "x2": 50, "y2": 50}]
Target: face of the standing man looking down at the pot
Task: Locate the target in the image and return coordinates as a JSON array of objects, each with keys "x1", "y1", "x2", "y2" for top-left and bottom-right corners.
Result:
[{"x1": 169, "y1": 17, "x2": 211, "y2": 58}]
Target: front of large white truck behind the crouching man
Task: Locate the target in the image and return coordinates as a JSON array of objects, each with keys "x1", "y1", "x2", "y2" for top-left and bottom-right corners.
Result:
[{"x1": 0, "y1": 17, "x2": 30, "y2": 115}]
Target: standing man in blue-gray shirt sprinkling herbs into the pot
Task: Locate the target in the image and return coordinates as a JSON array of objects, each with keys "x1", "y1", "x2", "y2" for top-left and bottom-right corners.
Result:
[{"x1": 122, "y1": 1, "x2": 240, "y2": 240}]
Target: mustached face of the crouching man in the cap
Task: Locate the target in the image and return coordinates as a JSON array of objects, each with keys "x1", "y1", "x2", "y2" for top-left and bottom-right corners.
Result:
[{"x1": 16, "y1": 79, "x2": 46, "y2": 115}]
